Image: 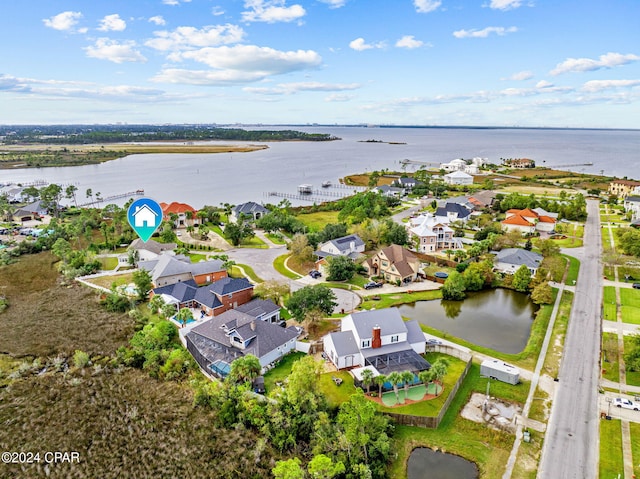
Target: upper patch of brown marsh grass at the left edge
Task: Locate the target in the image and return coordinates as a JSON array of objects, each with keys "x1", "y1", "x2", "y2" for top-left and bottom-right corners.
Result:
[{"x1": 0, "y1": 253, "x2": 133, "y2": 356}]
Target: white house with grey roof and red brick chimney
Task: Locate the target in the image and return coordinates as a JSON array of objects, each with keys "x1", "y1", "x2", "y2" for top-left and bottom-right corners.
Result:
[{"x1": 323, "y1": 308, "x2": 430, "y2": 375}]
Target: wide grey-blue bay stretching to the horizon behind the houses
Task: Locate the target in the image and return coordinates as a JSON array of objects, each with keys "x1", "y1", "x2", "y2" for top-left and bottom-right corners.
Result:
[{"x1": 0, "y1": 127, "x2": 640, "y2": 208}]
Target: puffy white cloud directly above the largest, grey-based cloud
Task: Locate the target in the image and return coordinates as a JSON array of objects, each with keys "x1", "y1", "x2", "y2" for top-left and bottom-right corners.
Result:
[{"x1": 145, "y1": 24, "x2": 244, "y2": 51}]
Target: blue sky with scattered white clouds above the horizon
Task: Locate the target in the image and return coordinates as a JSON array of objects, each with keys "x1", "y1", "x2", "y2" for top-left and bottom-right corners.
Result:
[{"x1": 0, "y1": 0, "x2": 640, "y2": 128}]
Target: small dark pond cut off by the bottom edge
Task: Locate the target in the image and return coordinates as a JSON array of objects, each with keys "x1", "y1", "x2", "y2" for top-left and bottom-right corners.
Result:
[{"x1": 407, "y1": 447, "x2": 478, "y2": 479}]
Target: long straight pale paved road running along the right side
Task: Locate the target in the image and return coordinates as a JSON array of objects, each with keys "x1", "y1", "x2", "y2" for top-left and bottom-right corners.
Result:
[{"x1": 538, "y1": 200, "x2": 602, "y2": 479}]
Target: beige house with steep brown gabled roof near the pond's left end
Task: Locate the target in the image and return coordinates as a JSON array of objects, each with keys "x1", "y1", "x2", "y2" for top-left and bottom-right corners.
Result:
[{"x1": 363, "y1": 244, "x2": 420, "y2": 283}]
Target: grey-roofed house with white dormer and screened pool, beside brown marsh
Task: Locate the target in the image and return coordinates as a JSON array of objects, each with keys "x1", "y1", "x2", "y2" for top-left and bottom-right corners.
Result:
[{"x1": 185, "y1": 309, "x2": 300, "y2": 378}]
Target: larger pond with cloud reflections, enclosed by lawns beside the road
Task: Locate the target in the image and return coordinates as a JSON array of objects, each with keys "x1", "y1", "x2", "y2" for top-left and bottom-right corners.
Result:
[{"x1": 399, "y1": 289, "x2": 536, "y2": 354}]
